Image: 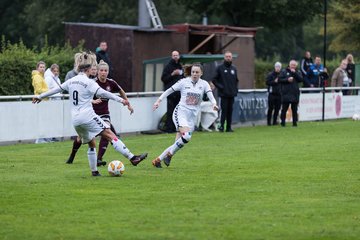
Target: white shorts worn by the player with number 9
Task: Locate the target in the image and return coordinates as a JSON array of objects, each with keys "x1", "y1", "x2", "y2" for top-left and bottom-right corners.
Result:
[{"x1": 74, "y1": 115, "x2": 110, "y2": 144}]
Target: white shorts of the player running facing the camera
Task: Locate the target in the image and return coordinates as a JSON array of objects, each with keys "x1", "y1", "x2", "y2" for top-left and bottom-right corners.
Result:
[{"x1": 173, "y1": 105, "x2": 197, "y2": 132}]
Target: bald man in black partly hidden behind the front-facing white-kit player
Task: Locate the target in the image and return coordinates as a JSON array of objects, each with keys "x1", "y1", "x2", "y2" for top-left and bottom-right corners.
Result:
[{"x1": 161, "y1": 51, "x2": 184, "y2": 133}]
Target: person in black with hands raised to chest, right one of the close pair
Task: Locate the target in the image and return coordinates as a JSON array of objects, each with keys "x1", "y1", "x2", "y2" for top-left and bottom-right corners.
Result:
[{"x1": 279, "y1": 60, "x2": 303, "y2": 127}]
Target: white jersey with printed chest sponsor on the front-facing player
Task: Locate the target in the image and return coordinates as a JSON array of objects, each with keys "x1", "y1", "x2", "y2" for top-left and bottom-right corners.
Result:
[{"x1": 171, "y1": 77, "x2": 212, "y2": 112}]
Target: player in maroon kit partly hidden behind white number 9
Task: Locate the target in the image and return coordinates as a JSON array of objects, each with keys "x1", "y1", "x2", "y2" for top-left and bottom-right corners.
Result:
[{"x1": 66, "y1": 60, "x2": 134, "y2": 166}]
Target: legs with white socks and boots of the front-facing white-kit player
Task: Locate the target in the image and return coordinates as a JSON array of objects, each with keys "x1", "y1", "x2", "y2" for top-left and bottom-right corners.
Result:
[{"x1": 152, "y1": 127, "x2": 191, "y2": 168}]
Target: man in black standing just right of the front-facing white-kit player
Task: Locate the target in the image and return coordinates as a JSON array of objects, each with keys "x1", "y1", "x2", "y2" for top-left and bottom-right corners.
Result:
[{"x1": 212, "y1": 51, "x2": 239, "y2": 132}]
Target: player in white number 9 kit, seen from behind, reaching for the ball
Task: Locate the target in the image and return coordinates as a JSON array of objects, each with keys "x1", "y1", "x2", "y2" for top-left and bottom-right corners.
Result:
[{"x1": 33, "y1": 52, "x2": 147, "y2": 176}]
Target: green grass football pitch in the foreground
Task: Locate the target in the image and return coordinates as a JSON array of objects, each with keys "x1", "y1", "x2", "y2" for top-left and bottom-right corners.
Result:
[{"x1": 0, "y1": 120, "x2": 360, "y2": 239}]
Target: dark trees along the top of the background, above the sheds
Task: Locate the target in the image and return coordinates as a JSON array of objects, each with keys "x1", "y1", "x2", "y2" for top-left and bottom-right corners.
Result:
[{"x1": 0, "y1": 0, "x2": 360, "y2": 60}]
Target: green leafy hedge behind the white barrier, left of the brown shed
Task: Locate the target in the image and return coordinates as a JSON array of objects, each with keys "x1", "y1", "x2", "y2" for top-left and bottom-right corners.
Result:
[{"x1": 0, "y1": 36, "x2": 83, "y2": 95}]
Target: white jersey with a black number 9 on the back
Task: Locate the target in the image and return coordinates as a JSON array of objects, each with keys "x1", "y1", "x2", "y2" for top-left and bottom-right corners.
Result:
[{"x1": 61, "y1": 73, "x2": 100, "y2": 125}]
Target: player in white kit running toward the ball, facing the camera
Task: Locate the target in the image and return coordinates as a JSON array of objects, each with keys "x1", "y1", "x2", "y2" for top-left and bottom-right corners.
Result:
[{"x1": 152, "y1": 64, "x2": 219, "y2": 168}]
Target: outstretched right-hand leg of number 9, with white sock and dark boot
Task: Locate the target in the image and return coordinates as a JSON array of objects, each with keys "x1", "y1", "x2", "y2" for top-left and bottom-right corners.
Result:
[{"x1": 100, "y1": 128, "x2": 148, "y2": 166}]
